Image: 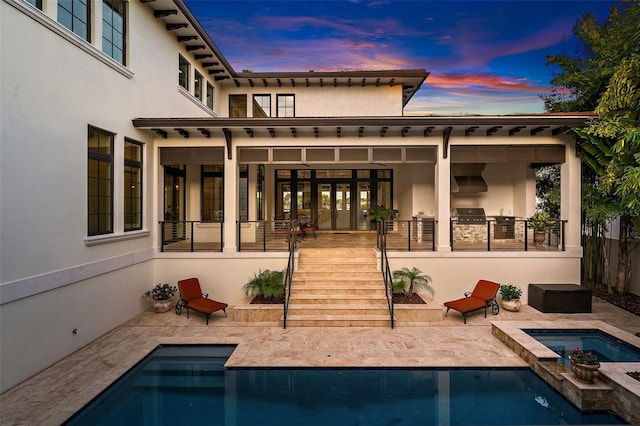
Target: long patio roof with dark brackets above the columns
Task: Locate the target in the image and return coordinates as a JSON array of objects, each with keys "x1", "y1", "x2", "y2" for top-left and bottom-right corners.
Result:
[{"x1": 132, "y1": 113, "x2": 595, "y2": 140}]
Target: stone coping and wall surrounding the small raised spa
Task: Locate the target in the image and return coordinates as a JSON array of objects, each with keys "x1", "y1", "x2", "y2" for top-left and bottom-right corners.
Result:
[{"x1": 491, "y1": 320, "x2": 640, "y2": 424}]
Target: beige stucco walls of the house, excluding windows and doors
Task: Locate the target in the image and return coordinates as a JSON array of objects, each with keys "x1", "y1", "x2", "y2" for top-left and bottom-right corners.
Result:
[{"x1": 0, "y1": 0, "x2": 596, "y2": 391}]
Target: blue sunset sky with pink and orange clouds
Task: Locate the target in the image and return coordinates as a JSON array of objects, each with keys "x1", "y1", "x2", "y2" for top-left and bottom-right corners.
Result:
[{"x1": 185, "y1": 0, "x2": 618, "y2": 115}]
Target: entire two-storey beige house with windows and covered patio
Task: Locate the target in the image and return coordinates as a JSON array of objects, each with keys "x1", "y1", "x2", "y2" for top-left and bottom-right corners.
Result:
[{"x1": 0, "y1": 0, "x2": 589, "y2": 391}]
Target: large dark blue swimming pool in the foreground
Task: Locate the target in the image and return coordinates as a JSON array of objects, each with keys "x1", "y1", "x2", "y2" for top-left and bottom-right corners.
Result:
[{"x1": 66, "y1": 345, "x2": 623, "y2": 426}]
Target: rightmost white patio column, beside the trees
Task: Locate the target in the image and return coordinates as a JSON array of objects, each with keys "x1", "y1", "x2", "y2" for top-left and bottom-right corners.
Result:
[{"x1": 560, "y1": 141, "x2": 582, "y2": 250}]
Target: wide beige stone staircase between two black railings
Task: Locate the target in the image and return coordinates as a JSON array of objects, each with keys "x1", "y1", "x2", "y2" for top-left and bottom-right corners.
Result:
[{"x1": 287, "y1": 248, "x2": 391, "y2": 327}]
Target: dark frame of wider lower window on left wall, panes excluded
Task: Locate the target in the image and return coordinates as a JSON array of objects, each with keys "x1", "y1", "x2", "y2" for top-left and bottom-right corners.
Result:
[{"x1": 87, "y1": 125, "x2": 115, "y2": 237}]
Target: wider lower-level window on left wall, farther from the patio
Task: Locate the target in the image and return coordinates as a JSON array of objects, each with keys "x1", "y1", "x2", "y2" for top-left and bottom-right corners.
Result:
[{"x1": 87, "y1": 127, "x2": 113, "y2": 236}]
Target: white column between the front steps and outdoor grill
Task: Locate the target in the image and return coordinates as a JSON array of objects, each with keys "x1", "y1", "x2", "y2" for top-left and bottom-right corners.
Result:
[{"x1": 434, "y1": 146, "x2": 451, "y2": 251}]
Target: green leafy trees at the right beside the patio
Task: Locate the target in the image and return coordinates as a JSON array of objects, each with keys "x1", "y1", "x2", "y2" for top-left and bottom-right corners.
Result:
[{"x1": 543, "y1": 0, "x2": 640, "y2": 293}]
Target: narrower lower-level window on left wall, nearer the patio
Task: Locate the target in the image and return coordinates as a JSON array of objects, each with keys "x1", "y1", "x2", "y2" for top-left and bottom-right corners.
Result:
[{"x1": 124, "y1": 140, "x2": 142, "y2": 231}]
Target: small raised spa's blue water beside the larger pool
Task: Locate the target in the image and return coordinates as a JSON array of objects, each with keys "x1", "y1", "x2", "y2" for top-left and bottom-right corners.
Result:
[{"x1": 522, "y1": 329, "x2": 640, "y2": 365}]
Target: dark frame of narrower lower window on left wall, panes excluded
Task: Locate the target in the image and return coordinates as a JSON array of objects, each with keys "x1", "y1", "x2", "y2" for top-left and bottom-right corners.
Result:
[{"x1": 123, "y1": 138, "x2": 144, "y2": 232}]
